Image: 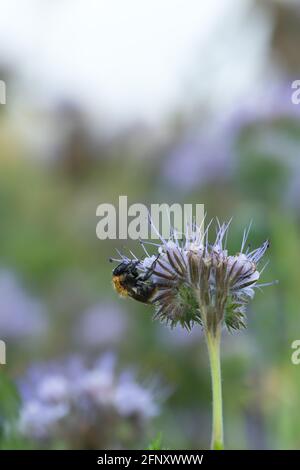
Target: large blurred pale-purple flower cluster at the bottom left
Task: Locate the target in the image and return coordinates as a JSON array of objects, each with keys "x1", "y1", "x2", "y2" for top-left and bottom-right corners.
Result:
[{"x1": 19, "y1": 354, "x2": 159, "y2": 448}]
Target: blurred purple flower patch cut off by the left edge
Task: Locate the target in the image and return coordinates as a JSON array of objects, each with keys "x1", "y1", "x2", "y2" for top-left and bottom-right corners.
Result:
[{"x1": 0, "y1": 269, "x2": 47, "y2": 339}]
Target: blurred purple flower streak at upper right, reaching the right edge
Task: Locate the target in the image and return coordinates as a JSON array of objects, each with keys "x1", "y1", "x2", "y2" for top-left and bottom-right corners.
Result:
[{"x1": 162, "y1": 80, "x2": 300, "y2": 191}]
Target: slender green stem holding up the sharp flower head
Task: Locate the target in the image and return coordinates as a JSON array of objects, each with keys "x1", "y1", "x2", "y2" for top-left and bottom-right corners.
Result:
[{"x1": 206, "y1": 326, "x2": 224, "y2": 450}]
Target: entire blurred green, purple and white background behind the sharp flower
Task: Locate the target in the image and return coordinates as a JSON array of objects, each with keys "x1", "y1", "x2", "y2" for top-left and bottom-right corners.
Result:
[{"x1": 0, "y1": 0, "x2": 300, "y2": 449}]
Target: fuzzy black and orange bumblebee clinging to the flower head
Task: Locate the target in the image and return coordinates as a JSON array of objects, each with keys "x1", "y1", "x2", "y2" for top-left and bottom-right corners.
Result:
[{"x1": 111, "y1": 258, "x2": 157, "y2": 304}]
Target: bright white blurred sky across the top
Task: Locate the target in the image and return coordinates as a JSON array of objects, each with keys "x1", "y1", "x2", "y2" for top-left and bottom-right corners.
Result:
[{"x1": 0, "y1": 0, "x2": 269, "y2": 126}]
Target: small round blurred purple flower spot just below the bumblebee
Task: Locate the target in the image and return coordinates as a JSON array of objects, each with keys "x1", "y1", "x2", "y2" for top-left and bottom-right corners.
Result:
[{"x1": 74, "y1": 302, "x2": 128, "y2": 347}]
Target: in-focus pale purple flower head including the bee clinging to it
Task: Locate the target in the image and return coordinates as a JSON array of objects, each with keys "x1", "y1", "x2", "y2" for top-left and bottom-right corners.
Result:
[{"x1": 114, "y1": 221, "x2": 269, "y2": 332}]
